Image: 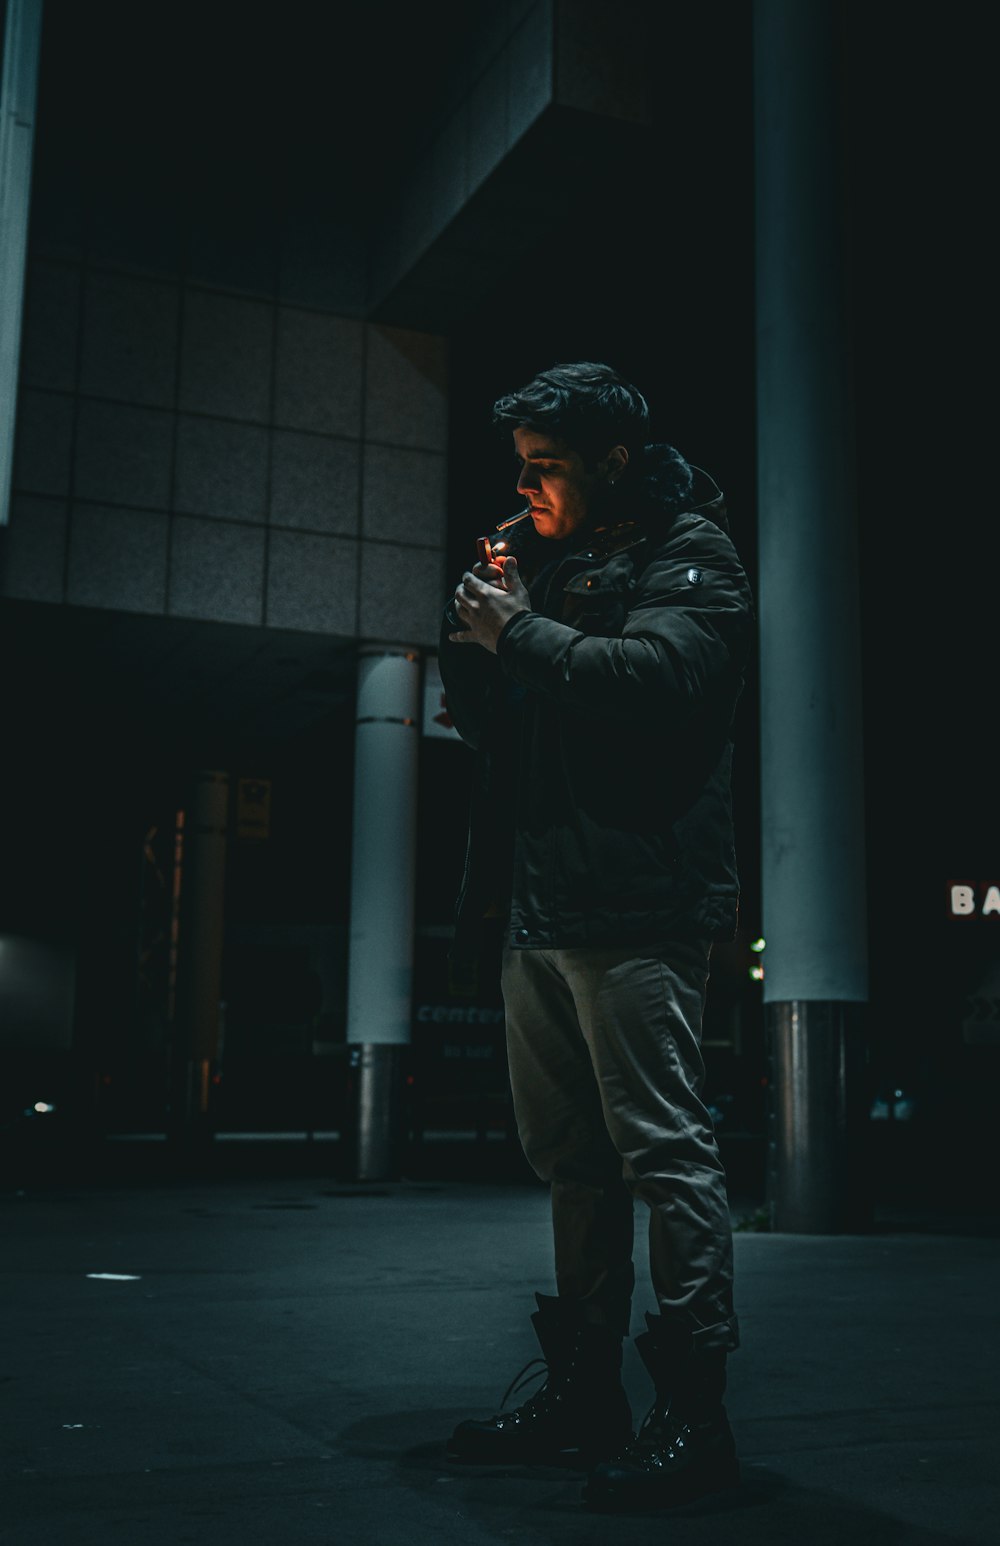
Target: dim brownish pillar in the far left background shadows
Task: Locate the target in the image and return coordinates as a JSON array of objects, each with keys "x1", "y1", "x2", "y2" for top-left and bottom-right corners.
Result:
[{"x1": 170, "y1": 770, "x2": 229, "y2": 1141}]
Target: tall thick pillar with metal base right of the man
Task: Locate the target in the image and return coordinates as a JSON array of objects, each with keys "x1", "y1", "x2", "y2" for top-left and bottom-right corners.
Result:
[{"x1": 754, "y1": 0, "x2": 869, "y2": 1232}]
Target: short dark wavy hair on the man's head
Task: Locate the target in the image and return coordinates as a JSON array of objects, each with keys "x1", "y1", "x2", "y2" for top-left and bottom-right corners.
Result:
[{"x1": 493, "y1": 360, "x2": 649, "y2": 461}]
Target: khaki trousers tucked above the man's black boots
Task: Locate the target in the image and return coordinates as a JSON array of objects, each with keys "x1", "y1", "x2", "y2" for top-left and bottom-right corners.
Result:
[{"x1": 502, "y1": 942, "x2": 739, "y2": 1348}]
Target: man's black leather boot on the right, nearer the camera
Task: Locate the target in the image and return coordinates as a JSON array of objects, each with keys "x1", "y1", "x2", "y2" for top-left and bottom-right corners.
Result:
[{"x1": 583, "y1": 1316, "x2": 739, "y2": 1514}]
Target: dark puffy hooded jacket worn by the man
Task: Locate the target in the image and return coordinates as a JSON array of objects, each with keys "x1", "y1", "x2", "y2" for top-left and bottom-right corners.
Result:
[{"x1": 440, "y1": 447, "x2": 754, "y2": 963}]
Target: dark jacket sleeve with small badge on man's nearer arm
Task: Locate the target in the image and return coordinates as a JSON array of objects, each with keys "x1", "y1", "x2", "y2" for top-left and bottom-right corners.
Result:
[{"x1": 496, "y1": 531, "x2": 754, "y2": 725}]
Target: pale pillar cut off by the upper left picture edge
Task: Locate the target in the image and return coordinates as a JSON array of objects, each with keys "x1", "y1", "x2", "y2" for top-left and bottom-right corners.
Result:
[{"x1": 0, "y1": 0, "x2": 42, "y2": 526}]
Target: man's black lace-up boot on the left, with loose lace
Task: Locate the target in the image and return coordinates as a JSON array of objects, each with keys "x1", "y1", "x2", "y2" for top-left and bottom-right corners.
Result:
[{"x1": 447, "y1": 1294, "x2": 632, "y2": 1466}]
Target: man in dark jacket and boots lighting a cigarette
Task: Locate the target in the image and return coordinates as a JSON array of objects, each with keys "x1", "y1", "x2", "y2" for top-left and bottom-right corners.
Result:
[{"x1": 440, "y1": 362, "x2": 753, "y2": 1509}]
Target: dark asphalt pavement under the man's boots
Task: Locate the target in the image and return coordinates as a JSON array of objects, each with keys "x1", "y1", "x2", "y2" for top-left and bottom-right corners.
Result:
[{"x1": 0, "y1": 1141, "x2": 1000, "y2": 1546}]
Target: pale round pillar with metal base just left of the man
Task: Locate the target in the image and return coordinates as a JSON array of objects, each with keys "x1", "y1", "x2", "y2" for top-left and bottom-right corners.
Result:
[{"x1": 346, "y1": 645, "x2": 420, "y2": 1181}]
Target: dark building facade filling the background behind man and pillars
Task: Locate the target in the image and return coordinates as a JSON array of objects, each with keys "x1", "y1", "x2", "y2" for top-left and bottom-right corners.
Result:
[{"x1": 0, "y1": 0, "x2": 1000, "y2": 1205}]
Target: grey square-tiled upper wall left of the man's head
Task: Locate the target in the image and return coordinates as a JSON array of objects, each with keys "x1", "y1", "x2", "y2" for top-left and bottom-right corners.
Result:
[{"x1": 2, "y1": 295, "x2": 448, "y2": 646}]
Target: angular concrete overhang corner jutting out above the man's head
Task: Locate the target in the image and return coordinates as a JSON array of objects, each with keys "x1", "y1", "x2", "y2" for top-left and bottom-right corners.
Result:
[{"x1": 366, "y1": 0, "x2": 657, "y2": 332}]
